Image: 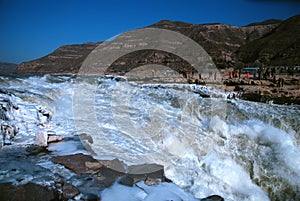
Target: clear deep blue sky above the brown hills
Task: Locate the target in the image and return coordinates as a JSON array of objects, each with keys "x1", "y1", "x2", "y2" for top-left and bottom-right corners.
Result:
[{"x1": 0, "y1": 0, "x2": 300, "y2": 63}]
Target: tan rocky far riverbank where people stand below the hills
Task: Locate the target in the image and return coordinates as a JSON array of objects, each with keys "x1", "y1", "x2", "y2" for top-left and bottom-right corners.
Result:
[{"x1": 115, "y1": 66, "x2": 300, "y2": 105}]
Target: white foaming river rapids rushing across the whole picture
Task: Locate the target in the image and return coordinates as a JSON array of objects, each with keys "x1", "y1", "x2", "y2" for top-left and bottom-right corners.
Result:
[{"x1": 0, "y1": 75, "x2": 300, "y2": 201}]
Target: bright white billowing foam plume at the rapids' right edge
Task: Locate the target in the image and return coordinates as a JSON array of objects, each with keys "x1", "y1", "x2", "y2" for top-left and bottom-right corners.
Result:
[{"x1": 233, "y1": 120, "x2": 300, "y2": 185}]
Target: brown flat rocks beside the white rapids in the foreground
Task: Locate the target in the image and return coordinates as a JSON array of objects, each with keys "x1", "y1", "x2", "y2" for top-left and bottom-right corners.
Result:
[{"x1": 52, "y1": 153, "x2": 165, "y2": 187}]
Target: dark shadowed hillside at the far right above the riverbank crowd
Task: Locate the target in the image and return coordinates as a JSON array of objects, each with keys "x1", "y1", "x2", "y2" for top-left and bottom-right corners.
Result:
[{"x1": 237, "y1": 15, "x2": 300, "y2": 66}]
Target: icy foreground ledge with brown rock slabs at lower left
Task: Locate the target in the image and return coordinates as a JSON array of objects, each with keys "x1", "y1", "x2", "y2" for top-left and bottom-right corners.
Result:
[{"x1": 0, "y1": 136, "x2": 224, "y2": 201}]
